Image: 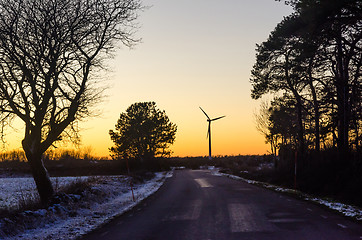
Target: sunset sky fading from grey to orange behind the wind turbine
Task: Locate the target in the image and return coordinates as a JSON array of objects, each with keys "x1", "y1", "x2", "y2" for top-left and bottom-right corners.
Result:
[{"x1": 6, "y1": 0, "x2": 292, "y2": 157}]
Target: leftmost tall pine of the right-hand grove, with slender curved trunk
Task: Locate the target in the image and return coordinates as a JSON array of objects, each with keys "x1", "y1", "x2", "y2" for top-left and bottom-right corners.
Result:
[{"x1": 251, "y1": 16, "x2": 305, "y2": 156}]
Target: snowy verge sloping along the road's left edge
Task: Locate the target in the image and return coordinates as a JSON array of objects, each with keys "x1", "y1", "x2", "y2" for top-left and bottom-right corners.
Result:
[{"x1": 1, "y1": 172, "x2": 172, "y2": 240}]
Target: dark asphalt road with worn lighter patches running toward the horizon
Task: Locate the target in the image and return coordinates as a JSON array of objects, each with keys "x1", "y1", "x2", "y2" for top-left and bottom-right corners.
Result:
[{"x1": 82, "y1": 170, "x2": 362, "y2": 240}]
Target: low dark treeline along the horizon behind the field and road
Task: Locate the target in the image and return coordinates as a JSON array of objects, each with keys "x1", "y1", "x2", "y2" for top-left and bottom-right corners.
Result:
[{"x1": 0, "y1": 150, "x2": 273, "y2": 177}]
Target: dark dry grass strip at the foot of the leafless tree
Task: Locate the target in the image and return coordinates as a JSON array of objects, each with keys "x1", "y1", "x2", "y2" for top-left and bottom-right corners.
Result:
[{"x1": 0, "y1": 177, "x2": 99, "y2": 239}]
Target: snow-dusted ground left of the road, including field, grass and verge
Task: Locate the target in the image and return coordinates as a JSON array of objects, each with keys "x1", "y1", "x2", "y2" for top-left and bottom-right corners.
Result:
[{"x1": 0, "y1": 172, "x2": 171, "y2": 240}]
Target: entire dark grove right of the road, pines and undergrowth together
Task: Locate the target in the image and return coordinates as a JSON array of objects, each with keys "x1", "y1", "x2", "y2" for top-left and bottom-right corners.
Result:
[{"x1": 250, "y1": 0, "x2": 362, "y2": 199}]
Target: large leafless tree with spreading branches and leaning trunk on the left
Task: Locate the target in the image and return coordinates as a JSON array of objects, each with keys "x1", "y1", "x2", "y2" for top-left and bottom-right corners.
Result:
[{"x1": 0, "y1": 0, "x2": 142, "y2": 203}]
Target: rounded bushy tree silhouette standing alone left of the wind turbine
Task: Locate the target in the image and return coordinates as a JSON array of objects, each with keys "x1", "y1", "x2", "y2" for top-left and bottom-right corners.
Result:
[{"x1": 109, "y1": 102, "x2": 177, "y2": 161}]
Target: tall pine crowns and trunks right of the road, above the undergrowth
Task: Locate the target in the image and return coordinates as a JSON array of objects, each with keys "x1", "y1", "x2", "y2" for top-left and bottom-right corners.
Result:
[{"x1": 251, "y1": 0, "x2": 362, "y2": 161}]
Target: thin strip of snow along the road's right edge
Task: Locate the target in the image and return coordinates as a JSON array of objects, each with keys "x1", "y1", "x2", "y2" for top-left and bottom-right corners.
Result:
[{"x1": 209, "y1": 168, "x2": 362, "y2": 221}]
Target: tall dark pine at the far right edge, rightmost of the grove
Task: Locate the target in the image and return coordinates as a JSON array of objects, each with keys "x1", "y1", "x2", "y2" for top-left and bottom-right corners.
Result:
[{"x1": 295, "y1": 0, "x2": 362, "y2": 160}]
